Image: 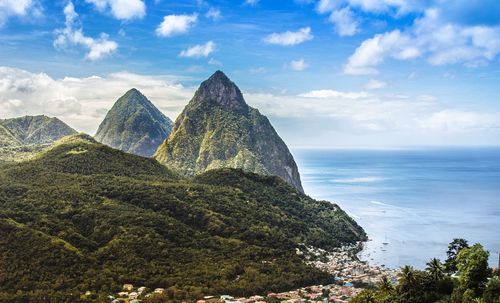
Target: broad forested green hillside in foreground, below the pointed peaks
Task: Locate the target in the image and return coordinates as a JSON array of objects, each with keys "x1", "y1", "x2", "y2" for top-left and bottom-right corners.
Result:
[{"x1": 0, "y1": 134, "x2": 366, "y2": 302}]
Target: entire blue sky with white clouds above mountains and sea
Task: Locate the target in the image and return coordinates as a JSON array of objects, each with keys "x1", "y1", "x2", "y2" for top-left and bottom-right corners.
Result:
[{"x1": 0, "y1": 0, "x2": 500, "y2": 148}]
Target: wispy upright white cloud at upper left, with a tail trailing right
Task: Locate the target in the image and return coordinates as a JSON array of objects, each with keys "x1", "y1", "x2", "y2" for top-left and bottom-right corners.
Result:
[{"x1": 54, "y1": 1, "x2": 118, "y2": 61}]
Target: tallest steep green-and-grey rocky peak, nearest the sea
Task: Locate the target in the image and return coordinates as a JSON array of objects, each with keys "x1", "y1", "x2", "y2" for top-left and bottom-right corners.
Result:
[{"x1": 154, "y1": 71, "x2": 303, "y2": 191}]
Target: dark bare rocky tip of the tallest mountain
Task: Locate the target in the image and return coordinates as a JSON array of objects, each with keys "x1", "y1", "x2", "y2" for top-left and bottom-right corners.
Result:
[{"x1": 192, "y1": 70, "x2": 248, "y2": 113}]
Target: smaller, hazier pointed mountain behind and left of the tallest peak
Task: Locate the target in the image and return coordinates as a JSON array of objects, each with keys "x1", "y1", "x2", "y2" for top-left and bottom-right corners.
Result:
[{"x1": 95, "y1": 88, "x2": 173, "y2": 157}]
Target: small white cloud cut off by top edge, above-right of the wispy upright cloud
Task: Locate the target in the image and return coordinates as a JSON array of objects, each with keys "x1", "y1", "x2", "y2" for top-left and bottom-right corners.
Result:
[{"x1": 85, "y1": 0, "x2": 146, "y2": 20}]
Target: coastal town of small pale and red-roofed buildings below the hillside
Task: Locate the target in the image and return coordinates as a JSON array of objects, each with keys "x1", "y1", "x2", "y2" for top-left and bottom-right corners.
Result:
[{"x1": 101, "y1": 242, "x2": 399, "y2": 303}]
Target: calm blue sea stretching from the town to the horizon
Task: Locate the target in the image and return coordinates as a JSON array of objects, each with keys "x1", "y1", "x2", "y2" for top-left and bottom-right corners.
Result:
[{"x1": 293, "y1": 148, "x2": 500, "y2": 269}]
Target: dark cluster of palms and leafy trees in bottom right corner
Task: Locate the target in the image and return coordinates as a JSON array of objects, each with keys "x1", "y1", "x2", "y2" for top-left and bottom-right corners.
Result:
[{"x1": 351, "y1": 239, "x2": 500, "y2": 303}]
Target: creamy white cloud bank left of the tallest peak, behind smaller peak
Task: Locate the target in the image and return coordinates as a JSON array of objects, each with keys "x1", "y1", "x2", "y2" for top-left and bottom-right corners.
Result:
[{"x1": 0, "y1": 67, "x2": 194, "y2": 134}]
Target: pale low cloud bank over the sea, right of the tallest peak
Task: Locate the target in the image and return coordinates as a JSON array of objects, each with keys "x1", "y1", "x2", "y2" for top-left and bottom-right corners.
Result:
[{"x1": 245, "y1": 89, "x2": 500, "y2": 146}]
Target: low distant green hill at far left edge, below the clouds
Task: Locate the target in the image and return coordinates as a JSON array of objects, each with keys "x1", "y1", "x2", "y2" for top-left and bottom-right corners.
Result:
[{"x1": 0, "y1": 115, "x2": 76, "y2": 147}]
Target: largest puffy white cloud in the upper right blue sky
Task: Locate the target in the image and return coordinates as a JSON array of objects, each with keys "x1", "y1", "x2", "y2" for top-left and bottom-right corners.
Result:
[{"x1": 344, "y1": 8, "x2": 500, "y2": 74}]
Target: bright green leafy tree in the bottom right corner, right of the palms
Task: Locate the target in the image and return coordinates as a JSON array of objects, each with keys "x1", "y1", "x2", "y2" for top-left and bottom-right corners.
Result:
[{"x1": 456, "y1": 243, "x2": 491, "y2": 294}]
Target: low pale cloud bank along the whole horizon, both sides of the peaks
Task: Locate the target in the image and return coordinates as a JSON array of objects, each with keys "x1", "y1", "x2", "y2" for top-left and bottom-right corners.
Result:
[{"x1": 0, "y1": 67, "x2": 500, "y2": 145}]
